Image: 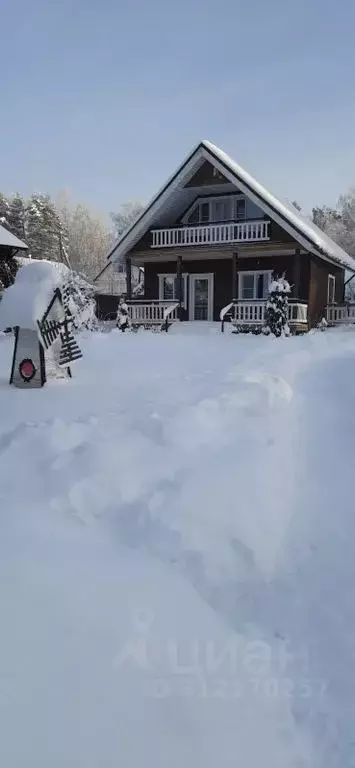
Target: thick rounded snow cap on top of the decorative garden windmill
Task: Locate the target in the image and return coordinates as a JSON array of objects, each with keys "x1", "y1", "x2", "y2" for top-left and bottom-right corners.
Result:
[{"x1": 0, "y1": 259, "x2": 69, "y2": 330}]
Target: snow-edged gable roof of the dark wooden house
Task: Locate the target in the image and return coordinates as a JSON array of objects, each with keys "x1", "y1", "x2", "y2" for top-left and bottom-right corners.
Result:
[{"x1": 107, "y1": 141, "x2": 355, "y2": 272}]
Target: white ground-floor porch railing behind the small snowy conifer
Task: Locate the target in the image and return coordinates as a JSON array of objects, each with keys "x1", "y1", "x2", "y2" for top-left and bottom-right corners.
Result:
[{"x1": 220, "y1": 299, "x2": 308, "y2": 330}]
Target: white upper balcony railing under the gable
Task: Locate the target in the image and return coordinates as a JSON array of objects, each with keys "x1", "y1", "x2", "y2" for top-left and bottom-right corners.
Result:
[{"x1": 152, "y1": 220, "x2": 270, "y2": 248}]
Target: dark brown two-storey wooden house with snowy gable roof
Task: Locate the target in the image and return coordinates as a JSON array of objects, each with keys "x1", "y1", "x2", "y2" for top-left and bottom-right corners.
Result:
[{"x1": 108, "y1": 141, "x2": 355, "y2": 330}]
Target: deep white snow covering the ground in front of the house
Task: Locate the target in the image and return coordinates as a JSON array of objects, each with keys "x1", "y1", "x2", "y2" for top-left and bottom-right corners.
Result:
[{"x1": 0, "y1": 324, "x2": 355, "y2": 768}]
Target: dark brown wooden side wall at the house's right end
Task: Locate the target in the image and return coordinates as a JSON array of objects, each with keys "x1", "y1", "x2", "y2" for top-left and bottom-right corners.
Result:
[{"x1": 308, "y1": 254, "x2": 344, "y2": 328}]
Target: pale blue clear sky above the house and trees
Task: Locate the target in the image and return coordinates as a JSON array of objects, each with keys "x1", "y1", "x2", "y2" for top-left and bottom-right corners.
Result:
[{"x1": 0, "y1": 0, "x2": 355, "y2": 219}]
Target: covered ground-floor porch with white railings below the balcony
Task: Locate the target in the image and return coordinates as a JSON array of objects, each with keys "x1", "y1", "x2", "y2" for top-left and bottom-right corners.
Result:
[{"x1": 127, "y1": 249, "x2": 308, "y2": 330}]
